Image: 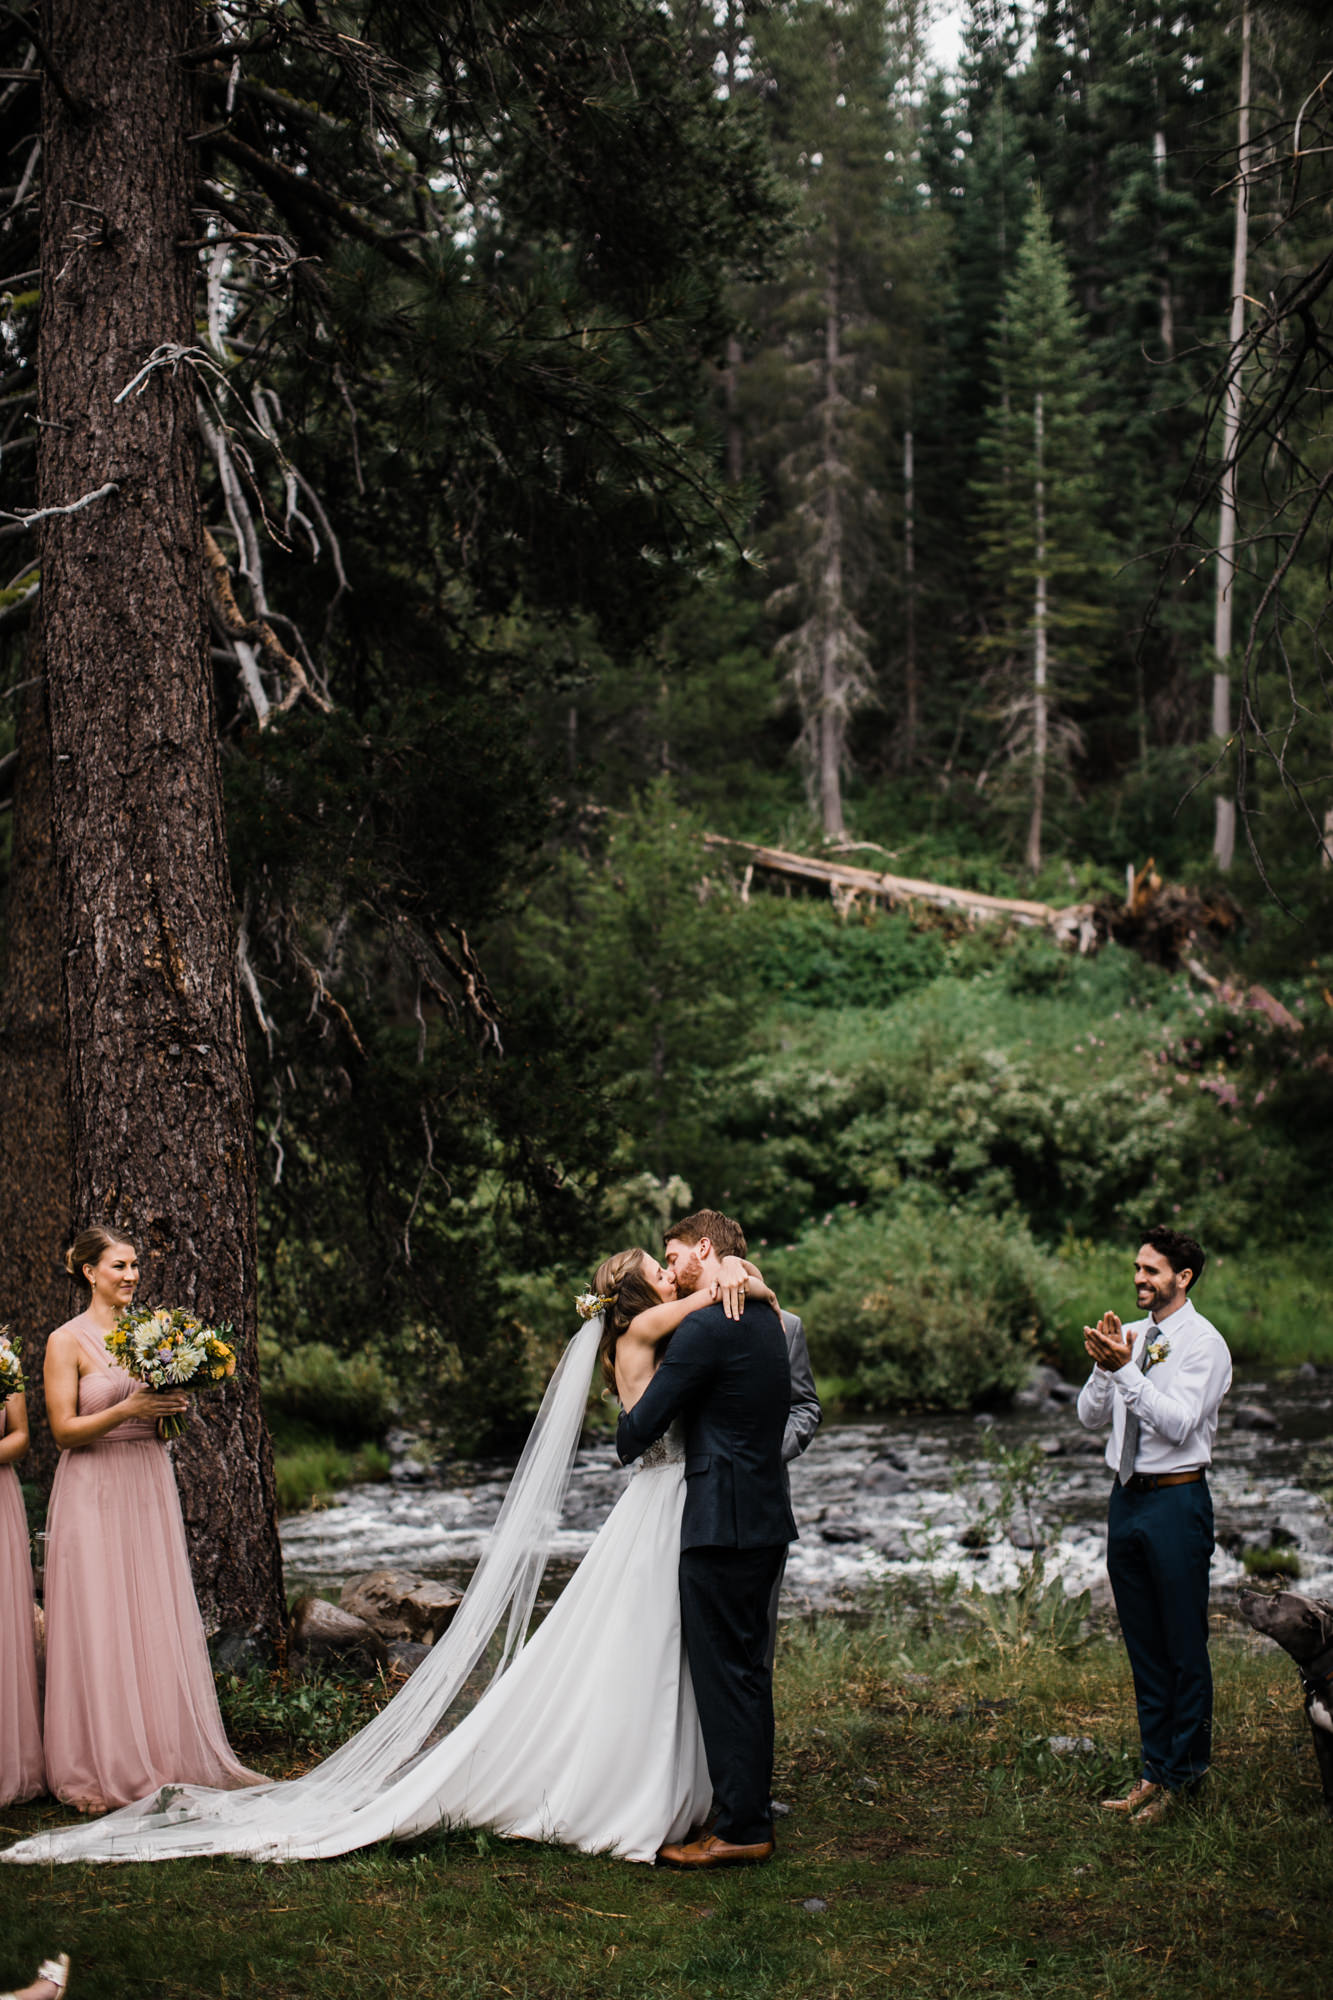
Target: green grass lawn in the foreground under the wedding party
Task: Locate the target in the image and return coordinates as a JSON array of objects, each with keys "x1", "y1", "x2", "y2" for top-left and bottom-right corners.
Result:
[{"x1": 0, "y1": 1616, "x2": 1333, "y2": 2000}]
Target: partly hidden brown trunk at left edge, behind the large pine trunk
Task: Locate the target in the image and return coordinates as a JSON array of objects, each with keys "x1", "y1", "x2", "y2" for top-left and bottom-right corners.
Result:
[{"x1": 0, "y1": 656, "x2": 74, "y2": 1490}]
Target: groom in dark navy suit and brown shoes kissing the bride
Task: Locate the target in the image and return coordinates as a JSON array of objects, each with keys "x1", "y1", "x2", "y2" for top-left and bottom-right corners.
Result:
[{"x1": 616, "y1": 1236, "x2": 797, "y2": 1868}]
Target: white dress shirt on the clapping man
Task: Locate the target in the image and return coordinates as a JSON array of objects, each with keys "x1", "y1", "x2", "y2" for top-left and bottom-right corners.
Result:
[{"x1": 1079, "y1": 1300, "x2": 1231, "y2": 1472}]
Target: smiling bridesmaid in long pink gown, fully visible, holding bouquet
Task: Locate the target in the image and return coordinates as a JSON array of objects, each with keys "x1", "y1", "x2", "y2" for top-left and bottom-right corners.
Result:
[{"x1": 46, "y1": 1226, "x2": 260, "y2": 1812}]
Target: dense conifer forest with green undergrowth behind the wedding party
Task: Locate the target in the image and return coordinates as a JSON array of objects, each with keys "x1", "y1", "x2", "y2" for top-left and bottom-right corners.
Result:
[{"x1": 0, "y1": 0, "x2": 1333, "y2": 1624}]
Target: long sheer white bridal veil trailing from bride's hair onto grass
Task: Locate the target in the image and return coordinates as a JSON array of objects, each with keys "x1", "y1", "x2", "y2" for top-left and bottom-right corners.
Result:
[{"x1": 0, "y1": 1316, "x2": 602, "y2": 1862}]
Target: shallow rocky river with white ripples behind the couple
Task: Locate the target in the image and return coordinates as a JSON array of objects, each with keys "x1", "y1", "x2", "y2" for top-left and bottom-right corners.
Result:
[{"x1": 282, "y1": 1366, "x2": 1333, "y2": 1614}]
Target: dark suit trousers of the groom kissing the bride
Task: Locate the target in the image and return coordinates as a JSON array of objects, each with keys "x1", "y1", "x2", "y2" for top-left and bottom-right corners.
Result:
[{"x1": 681, "y1": 1542, "x2": 787, "y2": 1846}]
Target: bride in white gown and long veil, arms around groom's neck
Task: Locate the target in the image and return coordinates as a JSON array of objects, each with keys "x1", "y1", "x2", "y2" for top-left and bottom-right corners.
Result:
[{"x1": 0, "y1": 1250, "x2": 773, "y2": 1862}]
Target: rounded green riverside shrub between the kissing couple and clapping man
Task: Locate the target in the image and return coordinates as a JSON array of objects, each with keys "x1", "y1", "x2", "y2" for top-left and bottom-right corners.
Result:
[{"x1": 765, "y1": 1204, "x2": 1061, "y2": 1410}]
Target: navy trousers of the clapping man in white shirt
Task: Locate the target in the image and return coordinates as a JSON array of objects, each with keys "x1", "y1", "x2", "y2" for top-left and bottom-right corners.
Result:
[{"x1": 1107, "y1": 1480, "x2": 1213, "y2": 1792}]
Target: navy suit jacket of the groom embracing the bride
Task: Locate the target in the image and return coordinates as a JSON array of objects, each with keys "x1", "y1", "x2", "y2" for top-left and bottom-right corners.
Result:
[{"x1": 616, "y1": 1300, "x2": 797, "y2": 1550}]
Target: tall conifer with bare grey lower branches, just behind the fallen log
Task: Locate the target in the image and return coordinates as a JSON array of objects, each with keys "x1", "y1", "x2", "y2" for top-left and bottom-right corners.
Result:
[{"x1": 751, "y1": 0, "x2": 897, "y2": 840}]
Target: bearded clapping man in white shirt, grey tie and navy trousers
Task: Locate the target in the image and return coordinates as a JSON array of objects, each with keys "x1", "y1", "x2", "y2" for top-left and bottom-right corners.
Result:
[{"x1": 1079, "y1": 1226, "x2": 1231, "y2": 1826}]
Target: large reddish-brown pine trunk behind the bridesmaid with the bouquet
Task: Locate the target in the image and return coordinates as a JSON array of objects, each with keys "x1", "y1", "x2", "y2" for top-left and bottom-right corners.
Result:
[{"x1": 38, "y1": 0, "x2": 282, "y2": 1638}]
